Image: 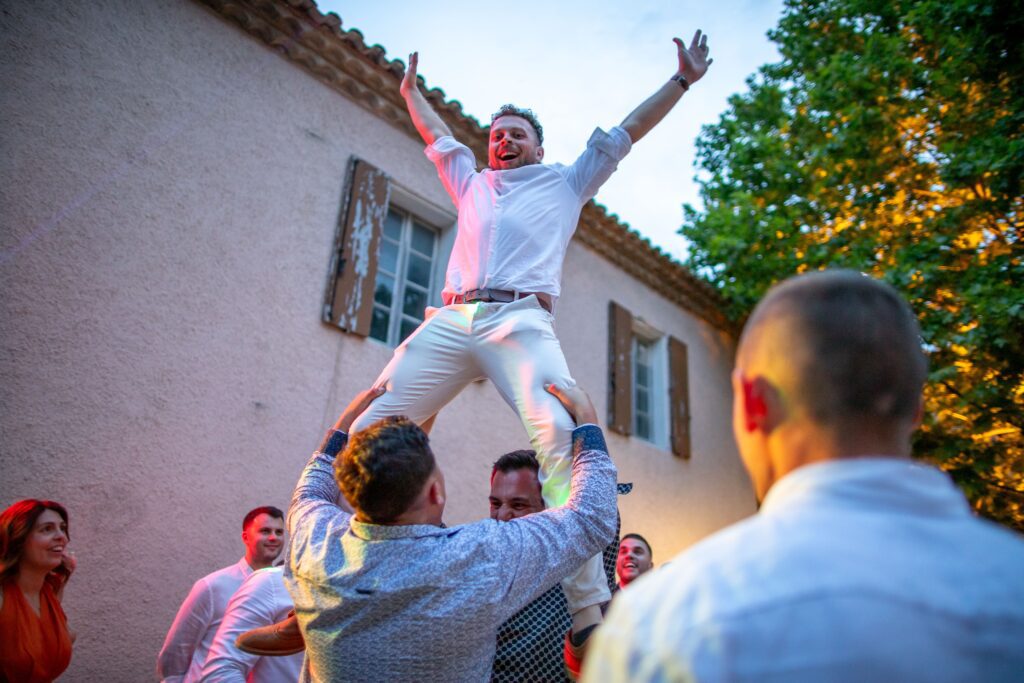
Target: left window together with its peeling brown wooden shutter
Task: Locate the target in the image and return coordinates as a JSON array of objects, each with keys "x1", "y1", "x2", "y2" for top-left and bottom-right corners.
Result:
[{"x1": 323, "y1": 159, "x2": 455, "y2": 346}]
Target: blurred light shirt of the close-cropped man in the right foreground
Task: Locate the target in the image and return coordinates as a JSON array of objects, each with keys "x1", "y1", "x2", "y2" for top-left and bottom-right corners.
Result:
[{"x1": 584, "y1": 458, "x2": 1024, "y2": 683}]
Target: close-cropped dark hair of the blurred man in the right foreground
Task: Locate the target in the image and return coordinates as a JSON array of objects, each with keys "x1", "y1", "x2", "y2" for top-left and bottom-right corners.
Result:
[{"x1": 744, "y1": 269, "x2": 928, "y2": 428}]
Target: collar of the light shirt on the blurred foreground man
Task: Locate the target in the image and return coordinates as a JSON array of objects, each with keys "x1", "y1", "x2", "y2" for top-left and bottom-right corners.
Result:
[{"x1": 761, "y1": 457, "x2": 970, "y2": 516}]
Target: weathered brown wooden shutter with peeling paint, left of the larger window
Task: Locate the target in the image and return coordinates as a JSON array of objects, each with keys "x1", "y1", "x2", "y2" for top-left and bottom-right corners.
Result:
[{"x1": 324, "y1": 157, "x2": 390, "y2": 337}]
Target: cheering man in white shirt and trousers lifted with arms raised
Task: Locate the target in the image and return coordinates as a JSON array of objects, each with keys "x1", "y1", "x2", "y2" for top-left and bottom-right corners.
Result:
[{"x1": 352, "y1": 31, "x2": 712, "y2": 663}]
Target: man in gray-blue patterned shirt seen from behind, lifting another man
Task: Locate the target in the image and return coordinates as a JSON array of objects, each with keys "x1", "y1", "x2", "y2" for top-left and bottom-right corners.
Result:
[{"x1": 286, "y1": 387, "x2": 615, "y2": 681}]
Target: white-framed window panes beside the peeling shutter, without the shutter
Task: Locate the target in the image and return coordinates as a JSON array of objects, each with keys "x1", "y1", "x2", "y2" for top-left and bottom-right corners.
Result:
[{"x1": 370, "y1": 208, "x2": 438, "y2": 346}]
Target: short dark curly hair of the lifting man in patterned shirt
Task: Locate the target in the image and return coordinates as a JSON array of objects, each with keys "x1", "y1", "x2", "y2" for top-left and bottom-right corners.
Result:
[{"x1": 334, "y1": 417, "x2": 436, "y2": 524}]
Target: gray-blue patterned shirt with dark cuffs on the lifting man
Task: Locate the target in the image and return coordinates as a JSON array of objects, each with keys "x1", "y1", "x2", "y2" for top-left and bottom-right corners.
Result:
[{"x1": 285, "y1": 425, "x2": 615, "y2": 681}]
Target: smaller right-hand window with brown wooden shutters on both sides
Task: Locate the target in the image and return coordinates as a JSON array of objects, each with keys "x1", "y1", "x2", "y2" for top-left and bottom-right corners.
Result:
[{"x1": 608, "y1": 301, "x2": 690, "y2": 458}]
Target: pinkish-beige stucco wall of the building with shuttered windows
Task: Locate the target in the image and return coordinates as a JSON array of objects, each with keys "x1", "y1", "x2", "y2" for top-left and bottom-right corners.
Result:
[{"x1": 0, "y1": 0, "x2": 753, "y2": 681}]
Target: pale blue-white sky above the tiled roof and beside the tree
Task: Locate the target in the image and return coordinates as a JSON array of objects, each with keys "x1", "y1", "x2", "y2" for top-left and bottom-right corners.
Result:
[{"x1": 317, "y1": 0, "x2": 782, "y2": 259}]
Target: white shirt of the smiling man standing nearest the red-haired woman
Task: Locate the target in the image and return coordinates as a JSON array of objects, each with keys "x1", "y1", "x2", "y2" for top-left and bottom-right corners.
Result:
[{"x1": 157, "y1": 557, "x2": 253, "y2": 683}]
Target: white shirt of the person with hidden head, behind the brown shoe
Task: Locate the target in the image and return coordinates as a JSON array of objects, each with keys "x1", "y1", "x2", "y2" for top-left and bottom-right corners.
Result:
[{"x1": 201, "y1": 567, "x2": 303, "y2": 683}]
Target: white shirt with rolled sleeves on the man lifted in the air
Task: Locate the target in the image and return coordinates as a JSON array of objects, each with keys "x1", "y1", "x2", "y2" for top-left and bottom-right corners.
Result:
[{"x1": 426, "y1": 126, "x2": 632, "y2": 303}]
